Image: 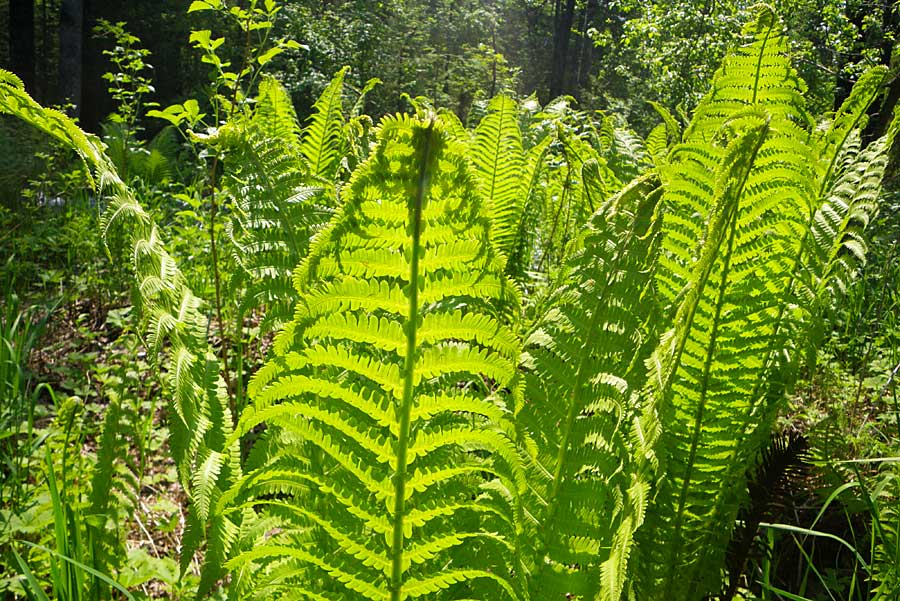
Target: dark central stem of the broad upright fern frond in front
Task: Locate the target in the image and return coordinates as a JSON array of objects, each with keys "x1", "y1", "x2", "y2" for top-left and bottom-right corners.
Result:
[{"x1": 391, "y1": 122, "x2": 434, "y2": 601}]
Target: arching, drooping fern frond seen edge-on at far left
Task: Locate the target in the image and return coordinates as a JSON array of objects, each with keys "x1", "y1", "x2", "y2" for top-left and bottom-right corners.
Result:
[{"x1": 0, "y1": 71, "x2": 241, "y2": 593}]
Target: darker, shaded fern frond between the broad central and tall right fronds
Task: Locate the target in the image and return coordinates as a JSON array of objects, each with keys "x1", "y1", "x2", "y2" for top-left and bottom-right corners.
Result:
[{"x1": 519, "y1": 171, "x2": 661, "y2": 601}]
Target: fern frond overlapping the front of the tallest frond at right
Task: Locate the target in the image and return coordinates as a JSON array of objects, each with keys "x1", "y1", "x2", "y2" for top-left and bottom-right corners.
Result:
[{"x1": 637, "y1": 115, "x2": 788, "y2": 599}]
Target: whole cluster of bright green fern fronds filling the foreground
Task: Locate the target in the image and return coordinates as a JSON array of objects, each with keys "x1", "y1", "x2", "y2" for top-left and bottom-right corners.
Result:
[{"x1": 0, "y1": 7, "x2": 897, "y2": 601}]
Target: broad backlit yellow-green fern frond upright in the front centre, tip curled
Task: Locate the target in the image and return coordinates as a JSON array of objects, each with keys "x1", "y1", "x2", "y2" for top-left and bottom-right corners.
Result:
[{"x1": 219, "y1": 117, "x2": 524, "y2": 601}]
